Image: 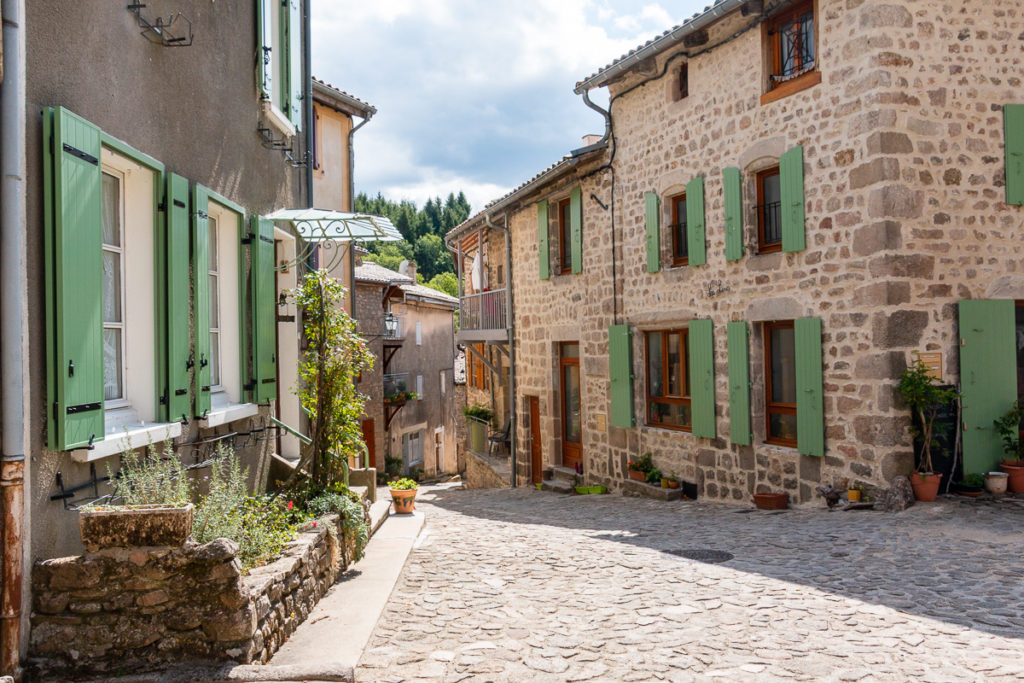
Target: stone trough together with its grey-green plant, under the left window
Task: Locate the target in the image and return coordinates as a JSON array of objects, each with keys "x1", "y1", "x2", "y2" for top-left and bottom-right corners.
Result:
[{"x1": 78, "y1": 441, "x2": 193, "y2": 552}]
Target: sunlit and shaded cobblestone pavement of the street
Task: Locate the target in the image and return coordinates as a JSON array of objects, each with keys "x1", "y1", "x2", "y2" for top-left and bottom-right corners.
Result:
[{"x1": 356, "y1": 488, "x2": 1024, "y2": 683}]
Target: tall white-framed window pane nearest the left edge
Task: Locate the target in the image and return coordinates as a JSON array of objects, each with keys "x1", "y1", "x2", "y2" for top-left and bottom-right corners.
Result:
[{"x1": 101, "y1": 171, "x2": 125, "y2": 407}]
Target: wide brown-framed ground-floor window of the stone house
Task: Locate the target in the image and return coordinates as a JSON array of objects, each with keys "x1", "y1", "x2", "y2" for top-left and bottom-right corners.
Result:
[{"x1": 646, "y1": 330, "x2": 692, "y2": 431}]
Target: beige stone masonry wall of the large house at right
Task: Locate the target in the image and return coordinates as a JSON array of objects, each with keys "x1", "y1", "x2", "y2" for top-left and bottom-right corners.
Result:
[{"x1": 499, "y1": 0, "x2": 1024, "y2": 503}]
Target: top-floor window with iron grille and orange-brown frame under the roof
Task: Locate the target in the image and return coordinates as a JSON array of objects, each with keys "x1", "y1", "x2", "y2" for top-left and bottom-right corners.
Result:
[{"x1": 761, "y1": 0, "x2": 821, "y2": 103}]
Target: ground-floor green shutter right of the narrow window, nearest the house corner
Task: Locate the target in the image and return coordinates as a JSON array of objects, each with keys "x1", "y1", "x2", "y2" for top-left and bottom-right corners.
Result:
[{"x1": 793, "y1": 317, "x2": 825, "y2": 456}]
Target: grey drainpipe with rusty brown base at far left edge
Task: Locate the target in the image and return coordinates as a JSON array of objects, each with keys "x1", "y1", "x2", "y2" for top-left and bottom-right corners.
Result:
[{"x1": 0, "y1": 0, "x2": 28, "y2": 678}]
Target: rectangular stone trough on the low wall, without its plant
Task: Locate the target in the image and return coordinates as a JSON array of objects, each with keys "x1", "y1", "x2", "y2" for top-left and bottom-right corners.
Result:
[{"x1": 78, "y1": 503, "x2": 193, "y2": 553}]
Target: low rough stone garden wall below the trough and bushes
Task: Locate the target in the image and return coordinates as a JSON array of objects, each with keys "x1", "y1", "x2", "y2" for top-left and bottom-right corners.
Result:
[{"x1": 30, "y1": 515, "x2": 360, "y2": 678}]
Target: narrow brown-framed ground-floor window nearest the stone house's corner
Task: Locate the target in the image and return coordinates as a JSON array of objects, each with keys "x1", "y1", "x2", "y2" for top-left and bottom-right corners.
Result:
[{"x1": 764, "y1": 321, "x2": 797, "y2": 446}]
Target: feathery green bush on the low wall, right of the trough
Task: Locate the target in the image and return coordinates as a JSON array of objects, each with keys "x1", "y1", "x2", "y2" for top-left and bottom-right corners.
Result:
[{"x1": 193, "y1": 446, "x2": 295, "y2": 569}]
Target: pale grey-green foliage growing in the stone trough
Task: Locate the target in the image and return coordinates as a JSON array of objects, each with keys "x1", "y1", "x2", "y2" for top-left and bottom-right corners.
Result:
[{"x1": 106, "y1": 440, "x2": 191, "y2": 505}]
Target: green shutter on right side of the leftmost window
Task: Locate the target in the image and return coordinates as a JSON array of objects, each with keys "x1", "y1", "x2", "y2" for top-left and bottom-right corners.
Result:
[{"x1": 158, "y1": 173, "x2": 191, "y2": 421}]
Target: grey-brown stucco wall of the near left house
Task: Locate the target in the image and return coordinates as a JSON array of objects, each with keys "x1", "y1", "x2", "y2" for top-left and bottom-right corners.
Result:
[{"x1": 26, "y1": 0, "x2": 307, "y2": 558}]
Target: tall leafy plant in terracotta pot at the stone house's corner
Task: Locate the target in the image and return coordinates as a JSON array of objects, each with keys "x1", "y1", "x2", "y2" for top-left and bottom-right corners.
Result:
[{"x1": 897, "y1": 358, "x2": 959, "y2": 503}]
